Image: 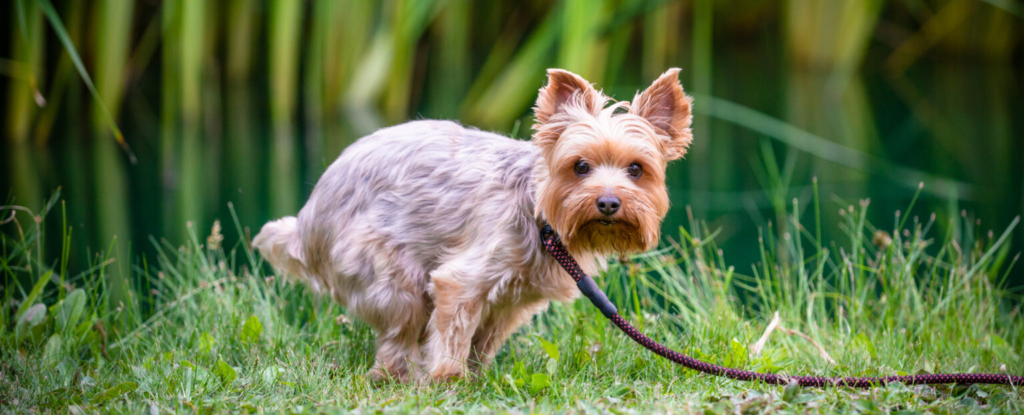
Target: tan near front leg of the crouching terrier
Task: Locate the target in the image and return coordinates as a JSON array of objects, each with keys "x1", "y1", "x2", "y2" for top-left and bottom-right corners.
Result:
[{"x1": 423, "y1": 266, "x2": 482, "y2": 380}]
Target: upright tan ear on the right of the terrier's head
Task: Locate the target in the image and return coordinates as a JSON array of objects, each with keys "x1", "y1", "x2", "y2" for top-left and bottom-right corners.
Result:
[{"x1": 630, "y1": 68, "x2": 693, "y2": 160}]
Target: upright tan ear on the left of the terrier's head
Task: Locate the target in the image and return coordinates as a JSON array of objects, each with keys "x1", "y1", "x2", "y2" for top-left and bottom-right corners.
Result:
[{"x1": 534, "y1": 69, "x2": 605, "y2": 148}]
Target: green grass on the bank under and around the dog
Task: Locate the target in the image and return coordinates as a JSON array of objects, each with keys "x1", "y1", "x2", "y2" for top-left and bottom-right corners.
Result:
[{"x1": 0, "y1": 189, "x2": 1024, "y2": 414}]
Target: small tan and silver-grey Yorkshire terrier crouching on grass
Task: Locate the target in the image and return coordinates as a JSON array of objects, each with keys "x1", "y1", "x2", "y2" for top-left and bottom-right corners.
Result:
[{"x1": 253, "y1": 69, "x2": 692, "y2": 381}]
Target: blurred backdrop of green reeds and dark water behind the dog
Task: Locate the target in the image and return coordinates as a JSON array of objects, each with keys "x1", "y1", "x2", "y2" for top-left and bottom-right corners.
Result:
[{"x1": 0, "y1": 0, "x2": 1024, "y2": 291}]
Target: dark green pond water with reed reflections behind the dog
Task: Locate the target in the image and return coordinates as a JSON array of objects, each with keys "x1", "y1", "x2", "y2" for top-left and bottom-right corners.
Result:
[{"x1": 0, "y1": 50, "x2": 1024, "y2": 285}]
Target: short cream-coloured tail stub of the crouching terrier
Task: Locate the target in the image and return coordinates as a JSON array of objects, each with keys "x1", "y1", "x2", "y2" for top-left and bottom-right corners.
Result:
[{"x1": 253, "y1": 216, "x2": 307, "y2": 280}]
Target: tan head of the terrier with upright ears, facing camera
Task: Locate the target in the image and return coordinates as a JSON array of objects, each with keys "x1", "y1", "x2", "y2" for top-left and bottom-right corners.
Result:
[{"x1": 534, "y1": 69, "x2": 693, "y2": 253}]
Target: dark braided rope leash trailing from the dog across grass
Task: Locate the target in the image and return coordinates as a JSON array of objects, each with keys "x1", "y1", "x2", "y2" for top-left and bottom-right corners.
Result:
[{"x1": 541, "y1": 224, "x2": 1024, "y2": 387}]
